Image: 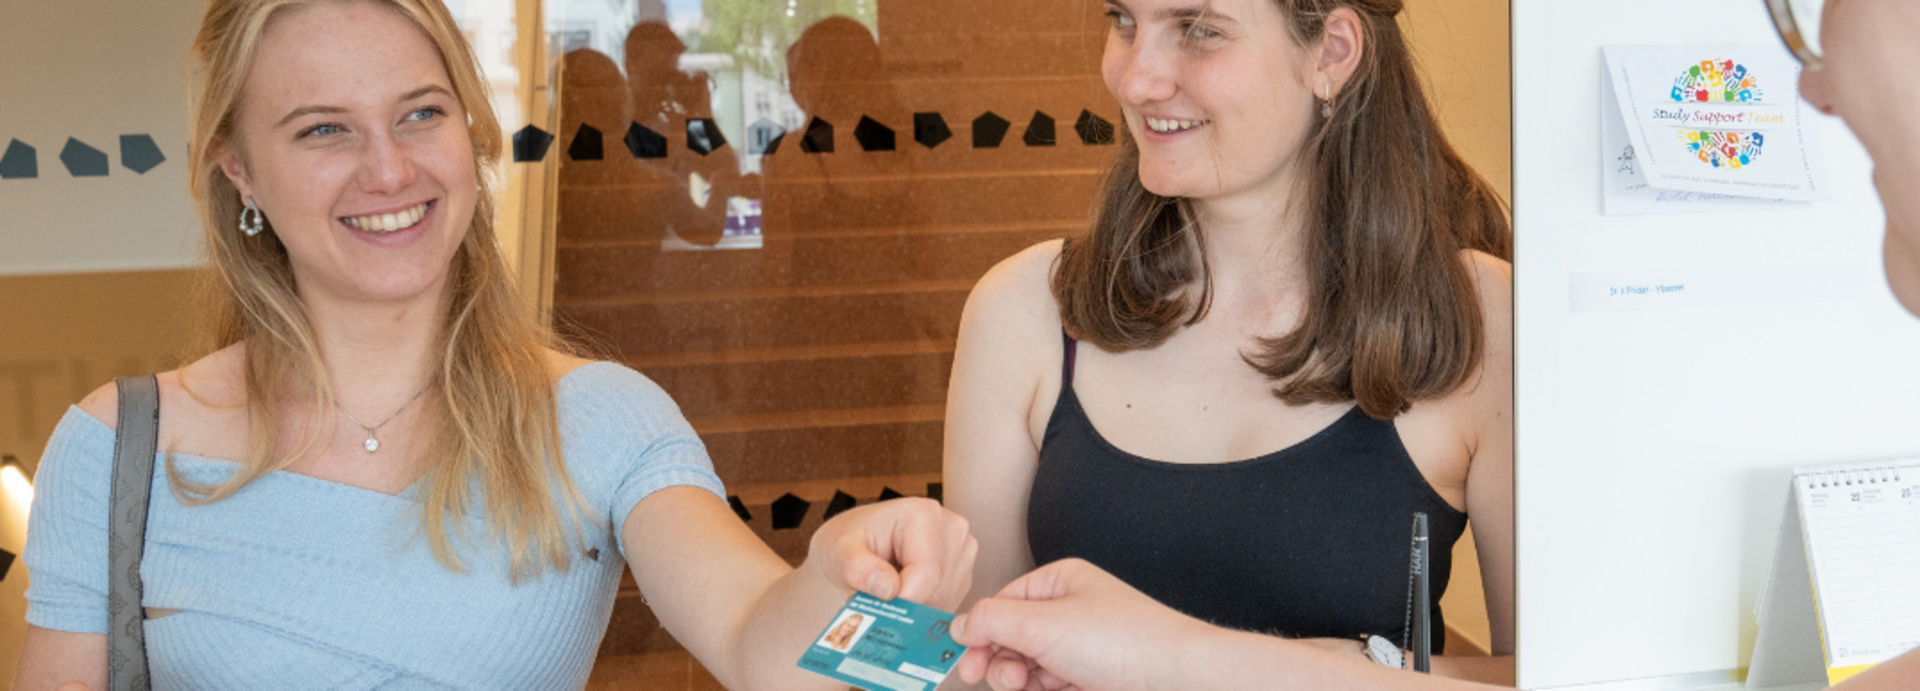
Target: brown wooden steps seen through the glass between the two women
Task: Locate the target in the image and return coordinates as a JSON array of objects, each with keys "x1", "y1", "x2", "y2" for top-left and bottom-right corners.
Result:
[{"x1": 555, "y1": 0, "x2": 1119, "y2": 689}]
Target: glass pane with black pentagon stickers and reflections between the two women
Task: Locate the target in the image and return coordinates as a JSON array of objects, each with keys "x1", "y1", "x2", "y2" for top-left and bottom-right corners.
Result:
[{"x1": 520, "y1": 0, "x2": 1119, "y2": 689}]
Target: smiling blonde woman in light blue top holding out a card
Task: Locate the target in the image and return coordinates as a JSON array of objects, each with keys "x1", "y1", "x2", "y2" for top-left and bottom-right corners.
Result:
[{"x1": 15, "y1": 0, "x2": 973, "y2": 689}]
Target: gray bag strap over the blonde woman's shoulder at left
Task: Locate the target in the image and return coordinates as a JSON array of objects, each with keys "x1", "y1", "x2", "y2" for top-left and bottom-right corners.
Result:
[{"x1": 108, "y1": 374, "x2": 159, "y2": 691}]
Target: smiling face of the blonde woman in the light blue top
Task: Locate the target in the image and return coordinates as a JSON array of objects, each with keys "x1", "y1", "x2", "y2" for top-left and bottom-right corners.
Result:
[{"x1": 217, "y1": 2, "x2": 478, "y2": 301}]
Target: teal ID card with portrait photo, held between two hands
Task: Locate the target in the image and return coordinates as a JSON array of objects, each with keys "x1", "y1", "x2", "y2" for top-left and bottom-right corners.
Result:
[{"x1": 801, "y1": 593, "x2": 966, "y2": 691}]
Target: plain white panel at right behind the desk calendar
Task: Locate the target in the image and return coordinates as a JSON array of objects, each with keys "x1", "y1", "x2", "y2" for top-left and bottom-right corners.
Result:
[{"x1": 1513, "y1": 0, "x2": 1920, "y2": 689}]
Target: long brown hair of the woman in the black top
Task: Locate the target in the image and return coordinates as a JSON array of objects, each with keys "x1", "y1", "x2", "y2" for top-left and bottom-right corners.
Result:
[{"x1": 1052, "y1": 0, "x2": 1513, "y2": 418}]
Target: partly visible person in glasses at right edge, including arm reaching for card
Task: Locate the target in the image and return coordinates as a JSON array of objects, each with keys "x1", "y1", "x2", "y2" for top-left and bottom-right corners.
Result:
[{"x1": 952, "y1": 0, "x2": 1920, "y2": 691}]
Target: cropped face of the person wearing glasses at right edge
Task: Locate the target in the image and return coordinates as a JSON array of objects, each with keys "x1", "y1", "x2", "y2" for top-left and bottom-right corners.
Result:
[{"x1": 1801, "y1": 0, "x2": 1920, "y2": 315}]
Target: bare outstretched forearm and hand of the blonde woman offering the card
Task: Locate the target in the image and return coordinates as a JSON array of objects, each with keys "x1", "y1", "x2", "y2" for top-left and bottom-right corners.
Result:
[{"x1": 624, "y1": 488, "x2": 977, "y2": 691}]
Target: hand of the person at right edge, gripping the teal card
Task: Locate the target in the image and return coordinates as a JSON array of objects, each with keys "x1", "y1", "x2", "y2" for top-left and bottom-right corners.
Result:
[{"x1": 952, "y1": 559, "x2": 1213, "y2": 691}]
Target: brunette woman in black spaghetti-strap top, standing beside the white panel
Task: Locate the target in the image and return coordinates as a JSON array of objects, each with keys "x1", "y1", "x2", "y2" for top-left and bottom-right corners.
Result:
[{"x1": 947, "y1": 0, "x2": 1513, "y2": 681}]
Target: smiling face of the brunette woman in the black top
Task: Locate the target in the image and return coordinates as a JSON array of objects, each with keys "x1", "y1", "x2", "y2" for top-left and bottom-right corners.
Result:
[{"x1": 1100, "y1": 0, "x2": 1327, "y2": 200}]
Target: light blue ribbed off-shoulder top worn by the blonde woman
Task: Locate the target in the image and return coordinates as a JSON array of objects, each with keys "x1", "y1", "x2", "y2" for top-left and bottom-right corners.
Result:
[{"x1": 23, "y1": 363, "x2": 726, "y2": 689}]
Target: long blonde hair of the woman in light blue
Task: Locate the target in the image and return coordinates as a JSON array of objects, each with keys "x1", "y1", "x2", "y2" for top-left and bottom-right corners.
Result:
[{"x1": 186, "y1": 0, "x2": 586, "y2": 582}]
